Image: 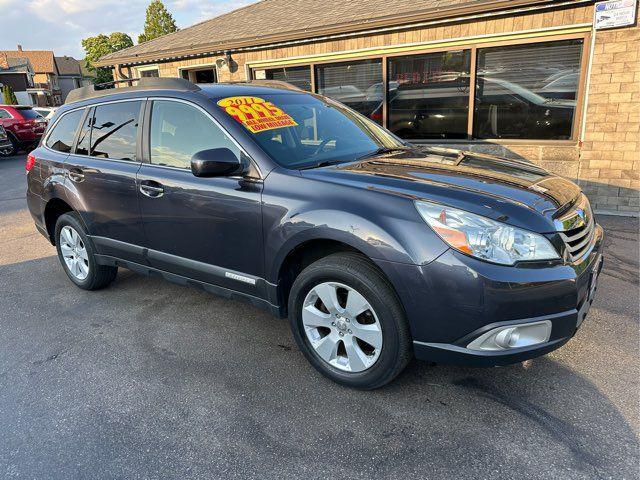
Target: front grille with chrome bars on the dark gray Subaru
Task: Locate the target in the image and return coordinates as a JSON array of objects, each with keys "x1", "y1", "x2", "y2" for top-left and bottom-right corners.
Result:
[{"x1": 555, "y1": 195, "x2": 596, "y2": 262}]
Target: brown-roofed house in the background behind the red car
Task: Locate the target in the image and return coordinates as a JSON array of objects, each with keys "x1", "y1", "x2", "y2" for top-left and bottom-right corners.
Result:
[{"x1": 0, "y1": 45, "x2": 62, "y2": 107}]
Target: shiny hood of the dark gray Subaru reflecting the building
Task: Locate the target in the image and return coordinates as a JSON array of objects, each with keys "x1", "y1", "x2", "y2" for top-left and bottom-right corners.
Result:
[{"x1": 302, "y1": 147, "x2": 580, "y2": 233}]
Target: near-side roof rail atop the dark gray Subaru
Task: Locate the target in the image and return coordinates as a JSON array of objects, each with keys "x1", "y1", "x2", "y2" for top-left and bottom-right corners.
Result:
[{"x1": 64, "y1": 77, "x2": 200, "y2": 105}]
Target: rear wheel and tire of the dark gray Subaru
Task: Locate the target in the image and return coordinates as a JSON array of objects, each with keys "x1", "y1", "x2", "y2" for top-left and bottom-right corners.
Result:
[{"x1": 55, "y1": 212, "x2": 118, "y2": 290}]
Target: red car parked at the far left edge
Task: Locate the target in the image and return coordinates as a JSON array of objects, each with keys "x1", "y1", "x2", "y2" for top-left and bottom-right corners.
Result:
[{"x1": 0, "y1": 105, "x2": 47, "y2": 151}]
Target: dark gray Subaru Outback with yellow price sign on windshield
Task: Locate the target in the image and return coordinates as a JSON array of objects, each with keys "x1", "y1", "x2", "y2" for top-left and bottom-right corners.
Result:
[{"x1": 27, "y1": 79, "x2": 603, "y2": 389}]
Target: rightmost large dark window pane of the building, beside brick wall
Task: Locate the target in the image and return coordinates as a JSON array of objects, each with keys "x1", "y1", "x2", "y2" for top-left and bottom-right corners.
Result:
[{"x1": 473, "y1": 40, "x2": 582, "y2": 140}]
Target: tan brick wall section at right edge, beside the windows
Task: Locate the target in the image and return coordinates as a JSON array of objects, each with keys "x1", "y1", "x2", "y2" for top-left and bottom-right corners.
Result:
[{"x1": 578, "y1": 18, "x2": 640, "y2": 214}]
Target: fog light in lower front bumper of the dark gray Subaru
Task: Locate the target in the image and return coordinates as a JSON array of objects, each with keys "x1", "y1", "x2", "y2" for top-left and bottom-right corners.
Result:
[{"x1": 467, "y1": 320, "x2": 551, "y2": 350}]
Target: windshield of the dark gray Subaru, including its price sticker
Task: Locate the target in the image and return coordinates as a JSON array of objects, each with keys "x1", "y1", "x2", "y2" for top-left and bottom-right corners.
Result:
[{"x1": 218, "y1": 93, "x2": 407, "y2": 169}]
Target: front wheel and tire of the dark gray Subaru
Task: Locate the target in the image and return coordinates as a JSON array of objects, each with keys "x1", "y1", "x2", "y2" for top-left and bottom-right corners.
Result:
[{"x1": 288, "y1": 253, "x2": 412, "y2": 390}]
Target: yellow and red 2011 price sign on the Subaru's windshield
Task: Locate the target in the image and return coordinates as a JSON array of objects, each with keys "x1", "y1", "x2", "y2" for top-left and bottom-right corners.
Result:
[{"x1": 218, "y1": 97, "x2": 298, "y2": 133}]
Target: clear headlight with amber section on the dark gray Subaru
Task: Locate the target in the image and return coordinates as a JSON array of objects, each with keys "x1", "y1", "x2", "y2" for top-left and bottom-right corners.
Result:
[{"x1": 416, "y1": 202, "x2": 560, "y2": 265}]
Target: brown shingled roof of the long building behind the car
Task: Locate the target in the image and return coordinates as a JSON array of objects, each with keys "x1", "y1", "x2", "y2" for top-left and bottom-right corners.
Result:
[{"x1": 96, "y1": 0, "x2": 557, "y2": 66}]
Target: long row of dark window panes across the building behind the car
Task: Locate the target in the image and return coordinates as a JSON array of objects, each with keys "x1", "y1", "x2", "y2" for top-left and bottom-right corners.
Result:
[{"x1": 252, "y1": 38, "x2": 585, "y2": 141}]
